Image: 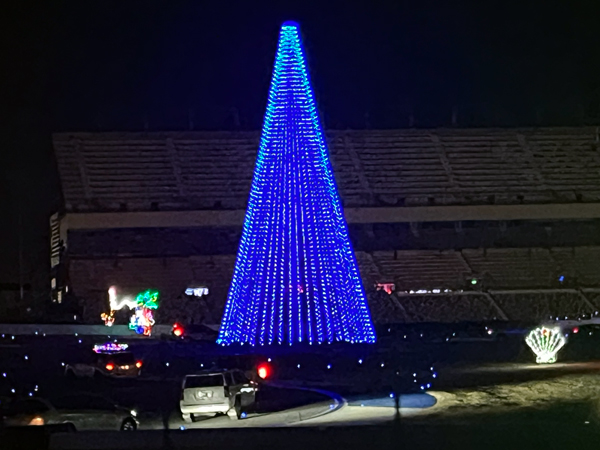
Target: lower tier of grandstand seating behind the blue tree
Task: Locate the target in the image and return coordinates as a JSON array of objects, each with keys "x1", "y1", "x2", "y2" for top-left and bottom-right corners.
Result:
[{"x1": 70, "y1": 247, "x2": 600, "y2": 323}]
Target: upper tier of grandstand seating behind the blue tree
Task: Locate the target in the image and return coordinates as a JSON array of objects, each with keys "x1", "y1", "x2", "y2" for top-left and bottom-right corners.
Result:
[{"x1": 54, "y1": 127, "x2": 600, "y2": 211}]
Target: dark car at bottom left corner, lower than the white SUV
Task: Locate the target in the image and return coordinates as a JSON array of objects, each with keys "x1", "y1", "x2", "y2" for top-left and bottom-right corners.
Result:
[{"x1": 2, "y1": 394, "x2": 138, "y2": 431}]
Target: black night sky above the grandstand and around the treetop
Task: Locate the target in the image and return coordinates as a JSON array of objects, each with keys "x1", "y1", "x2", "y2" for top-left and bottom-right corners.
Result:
[{"x1": 0, "y1": 0, "x2": 600, "y2": 282}]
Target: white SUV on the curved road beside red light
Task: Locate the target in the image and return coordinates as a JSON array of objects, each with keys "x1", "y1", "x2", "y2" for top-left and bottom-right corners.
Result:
[{"x1": 179, "y1": 370, "x2": 258, "y2": 422}]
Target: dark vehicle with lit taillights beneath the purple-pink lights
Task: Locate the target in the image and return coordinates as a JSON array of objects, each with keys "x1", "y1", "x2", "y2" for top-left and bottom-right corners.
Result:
[{"x1": 65, "y1": 352, "x2": 142, "y2": 378}]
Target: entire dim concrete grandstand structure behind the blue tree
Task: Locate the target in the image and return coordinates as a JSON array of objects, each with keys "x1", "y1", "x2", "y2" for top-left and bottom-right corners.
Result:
[{"x1": 50, "y1": 127, "x2": 600, "y2": 323}]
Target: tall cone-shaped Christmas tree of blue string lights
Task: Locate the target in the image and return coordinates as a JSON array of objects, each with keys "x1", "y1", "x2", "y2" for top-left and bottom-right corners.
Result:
[{"x1": 217, "y1": 22, "x2": 375, "y2": 345}]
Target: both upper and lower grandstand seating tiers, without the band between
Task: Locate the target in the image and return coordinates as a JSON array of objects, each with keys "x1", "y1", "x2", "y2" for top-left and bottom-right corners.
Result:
[{"x1": 54, "y1": 127, "x2": 600, "y2": 323}]
